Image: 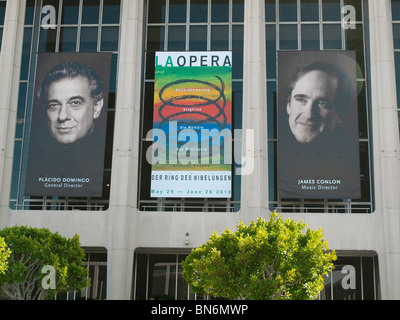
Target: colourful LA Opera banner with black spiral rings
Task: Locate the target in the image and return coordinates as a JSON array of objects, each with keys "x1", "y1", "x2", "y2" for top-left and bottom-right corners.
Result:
[{"x1": 151, "y1": 52, "x2": 232, "y2": 198}]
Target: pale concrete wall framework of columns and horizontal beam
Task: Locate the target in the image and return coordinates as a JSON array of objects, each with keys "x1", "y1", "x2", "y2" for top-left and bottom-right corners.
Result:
[{"x1": 0, "y1": 0, "x2": 400, "y2": 299}]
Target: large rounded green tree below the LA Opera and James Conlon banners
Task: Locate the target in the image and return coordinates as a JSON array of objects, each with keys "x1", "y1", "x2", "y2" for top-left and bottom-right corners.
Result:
[{"x1": 182, "y1": 212, "x2": 336, "y2": 300}]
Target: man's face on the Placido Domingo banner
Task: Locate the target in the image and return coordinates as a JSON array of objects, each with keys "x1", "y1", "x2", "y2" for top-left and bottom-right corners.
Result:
[{"x1": 47, "y1": 76, "x2": 103, "y2": 144}]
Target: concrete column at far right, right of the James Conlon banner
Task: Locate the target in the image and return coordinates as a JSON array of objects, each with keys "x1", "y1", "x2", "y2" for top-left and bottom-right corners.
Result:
[{"x1": 369, "y1": 0, "x2": 400, "y2": 299}]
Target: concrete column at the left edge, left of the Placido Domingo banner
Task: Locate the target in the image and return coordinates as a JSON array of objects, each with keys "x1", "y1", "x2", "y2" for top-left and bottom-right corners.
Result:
[{"x1": 0, "y1": 0, "x2": 26, "y2": 228}]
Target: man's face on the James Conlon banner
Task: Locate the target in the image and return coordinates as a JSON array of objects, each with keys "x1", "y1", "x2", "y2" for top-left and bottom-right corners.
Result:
[{"x1": 286, "y1": 70, "x2": 339, "y2": 143}]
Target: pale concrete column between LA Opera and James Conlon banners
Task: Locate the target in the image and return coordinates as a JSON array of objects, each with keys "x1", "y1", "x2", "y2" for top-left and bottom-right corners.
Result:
[{"x1": 241, "y1": 0, "x2": 268, "y2": 220}]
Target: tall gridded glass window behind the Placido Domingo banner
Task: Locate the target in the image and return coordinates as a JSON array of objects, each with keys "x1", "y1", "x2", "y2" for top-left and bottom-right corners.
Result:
[{"x1": 10, "y1": 0, "x2": 120, "y2": 210}]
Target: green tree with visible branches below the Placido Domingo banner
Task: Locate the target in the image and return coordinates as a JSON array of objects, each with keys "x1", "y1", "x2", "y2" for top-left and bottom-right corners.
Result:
[{"x1": 0, "y1": 226, "x2": 90, "y2": 300}]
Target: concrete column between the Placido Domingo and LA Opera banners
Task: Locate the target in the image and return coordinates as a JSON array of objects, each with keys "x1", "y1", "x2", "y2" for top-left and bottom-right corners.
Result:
[{"x1": 107, "y1": 0, "x2": 143, "y2": 300}]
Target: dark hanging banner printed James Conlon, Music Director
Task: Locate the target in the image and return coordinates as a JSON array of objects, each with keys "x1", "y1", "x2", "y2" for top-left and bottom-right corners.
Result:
[{"x1": 278, "y1": 51, "x2": 362, "y2": 199}]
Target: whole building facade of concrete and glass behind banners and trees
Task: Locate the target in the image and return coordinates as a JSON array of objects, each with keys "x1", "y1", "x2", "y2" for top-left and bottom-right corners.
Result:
[{"x1": 0, "y1": 0, "x2": 400, "y2": 300}]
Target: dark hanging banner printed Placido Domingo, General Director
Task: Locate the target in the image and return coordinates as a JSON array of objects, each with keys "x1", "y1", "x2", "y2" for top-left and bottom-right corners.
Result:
[{"x1": 25, "y1": 53, "x2": 111, "y2": 197}]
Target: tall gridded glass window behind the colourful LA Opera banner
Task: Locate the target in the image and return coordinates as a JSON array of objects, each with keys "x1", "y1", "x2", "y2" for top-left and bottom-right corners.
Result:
[{"x1": 138, "y1": 0, "x2": 244, "y2": 212}]
